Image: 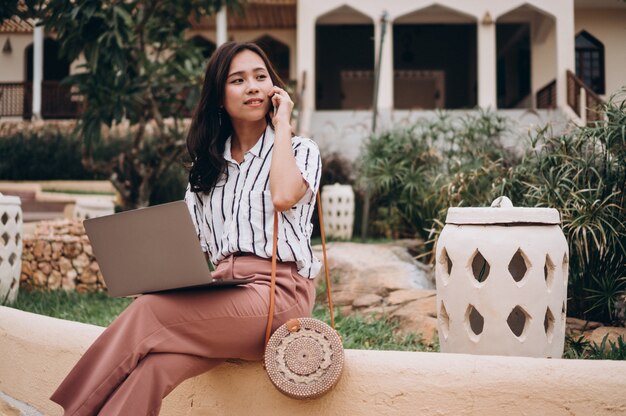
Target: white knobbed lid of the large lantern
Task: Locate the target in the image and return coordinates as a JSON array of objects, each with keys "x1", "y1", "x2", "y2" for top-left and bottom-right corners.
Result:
[{"x1": 446, "y1": 196, "x2": 561, "y2": 225}]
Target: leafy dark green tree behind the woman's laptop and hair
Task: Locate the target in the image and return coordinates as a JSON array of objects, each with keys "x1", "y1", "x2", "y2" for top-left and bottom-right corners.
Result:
[{"x1": 0, "y1": 0, "x2": 240, "y2": 209}]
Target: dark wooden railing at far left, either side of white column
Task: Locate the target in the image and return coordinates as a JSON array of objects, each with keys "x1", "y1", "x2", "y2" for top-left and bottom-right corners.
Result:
[{"x1": 0, "y1": 81, "x2": 82, "y2": 119}]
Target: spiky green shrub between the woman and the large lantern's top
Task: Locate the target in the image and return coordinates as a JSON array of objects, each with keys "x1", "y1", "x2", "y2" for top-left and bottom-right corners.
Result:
[{"x1": 359, "y1": 112, "x2": 515, "y2": 247}]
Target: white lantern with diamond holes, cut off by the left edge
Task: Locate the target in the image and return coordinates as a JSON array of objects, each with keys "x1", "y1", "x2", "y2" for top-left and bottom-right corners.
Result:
[{"x1": 0, "y1": 194, "x2": 23, "y2": 305}]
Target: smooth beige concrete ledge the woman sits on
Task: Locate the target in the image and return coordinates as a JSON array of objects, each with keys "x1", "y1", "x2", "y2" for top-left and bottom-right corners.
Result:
[{"x1": 0, "y1": 307, "x2": 626, "y2": 416}]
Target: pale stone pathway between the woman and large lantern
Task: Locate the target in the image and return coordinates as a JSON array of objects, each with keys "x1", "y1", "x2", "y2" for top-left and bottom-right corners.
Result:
[{"x1": 316, "y1": 240, "x2": 437, "y2": 345}]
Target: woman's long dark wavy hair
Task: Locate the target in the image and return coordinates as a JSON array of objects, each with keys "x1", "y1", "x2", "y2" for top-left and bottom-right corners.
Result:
[{"x1": 187, "y1": 42, "x2": 284, "y2": 192}]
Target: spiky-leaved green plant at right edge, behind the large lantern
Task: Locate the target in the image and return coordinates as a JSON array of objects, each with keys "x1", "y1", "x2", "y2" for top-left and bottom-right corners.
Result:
[{"x1": 509, "y1": 90, "x2": 626, "y2": 322}]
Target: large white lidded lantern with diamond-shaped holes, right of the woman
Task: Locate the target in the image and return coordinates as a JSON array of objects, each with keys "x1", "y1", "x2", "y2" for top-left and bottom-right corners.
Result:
[{"x1": 436, "y1": 197, "x2": 568, "y2": 358}]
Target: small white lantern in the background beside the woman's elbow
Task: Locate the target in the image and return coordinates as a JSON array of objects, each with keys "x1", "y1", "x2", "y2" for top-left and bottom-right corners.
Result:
[{"x1": 322, "y1": 183, "x2": 354, "y2": 240}]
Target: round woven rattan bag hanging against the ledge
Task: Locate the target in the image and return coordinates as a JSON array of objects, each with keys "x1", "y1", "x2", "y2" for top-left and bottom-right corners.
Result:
[{"x1": 265, "y1": 318, "x2": 344, "y2": 399}]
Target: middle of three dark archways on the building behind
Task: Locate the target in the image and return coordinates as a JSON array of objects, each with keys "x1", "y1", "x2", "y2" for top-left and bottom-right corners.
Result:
[{"x1": 393, "y1": 5, "x2": 477, "y2": 109}]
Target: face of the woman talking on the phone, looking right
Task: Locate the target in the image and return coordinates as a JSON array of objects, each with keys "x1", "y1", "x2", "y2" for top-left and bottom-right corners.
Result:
[{"x1": 224, "y1": 49, "x2": 273, "y2": 123}]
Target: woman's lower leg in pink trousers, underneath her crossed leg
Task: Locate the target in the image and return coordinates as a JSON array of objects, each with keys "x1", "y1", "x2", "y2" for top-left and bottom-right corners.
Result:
[{"x1": 98, "y1": 353, "x2": 223, "y2": 416}]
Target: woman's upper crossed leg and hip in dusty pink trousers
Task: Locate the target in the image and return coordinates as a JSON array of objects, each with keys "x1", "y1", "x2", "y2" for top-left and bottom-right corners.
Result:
[{"x1": 51, "y1": 257, "x2": 314, "y2": 415}]
